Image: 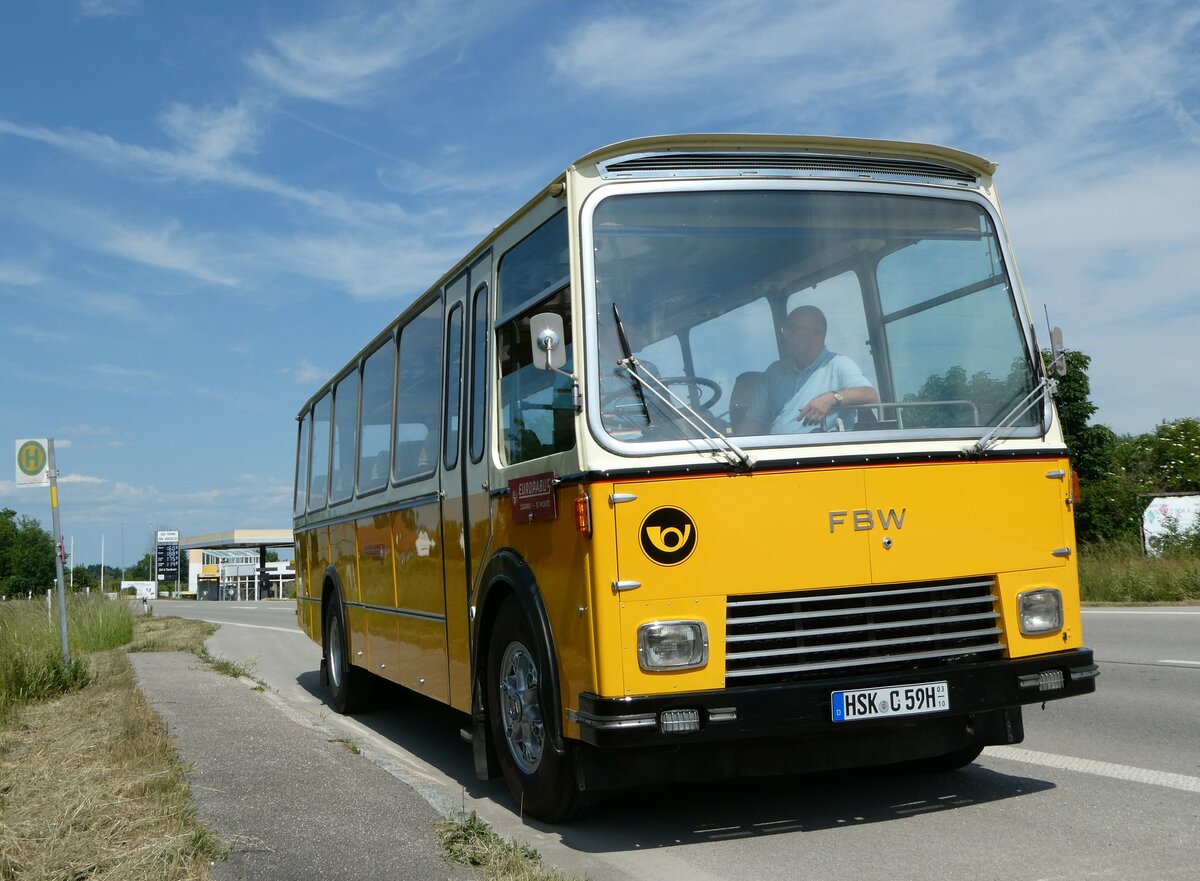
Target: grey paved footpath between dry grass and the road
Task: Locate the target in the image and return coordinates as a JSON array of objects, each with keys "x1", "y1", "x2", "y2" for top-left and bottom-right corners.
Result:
[{"x1": 128, "y1": 653, "x2": 473, "y2": 881}]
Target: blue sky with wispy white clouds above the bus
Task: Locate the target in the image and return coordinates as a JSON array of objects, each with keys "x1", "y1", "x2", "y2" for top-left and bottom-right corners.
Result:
[{"x1": 0, "y1": 0, "x2": 1200, "y2": 564}]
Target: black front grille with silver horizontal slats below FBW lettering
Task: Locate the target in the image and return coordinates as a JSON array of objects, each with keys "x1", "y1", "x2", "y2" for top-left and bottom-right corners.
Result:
[{"x1": 725, "y1": 579, "x2": 1003, "y2": 685}]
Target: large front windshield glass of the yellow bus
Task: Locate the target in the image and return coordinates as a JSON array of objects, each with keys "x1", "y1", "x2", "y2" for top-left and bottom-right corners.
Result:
[{"x1": 584, "y1": 187, "x2": 1043, "y2": 447}]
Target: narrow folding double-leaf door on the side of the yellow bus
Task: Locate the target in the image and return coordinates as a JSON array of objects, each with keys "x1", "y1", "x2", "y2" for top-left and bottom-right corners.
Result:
[{"x1": 442, "y1": 252, "x2": 492, "y2": 711}]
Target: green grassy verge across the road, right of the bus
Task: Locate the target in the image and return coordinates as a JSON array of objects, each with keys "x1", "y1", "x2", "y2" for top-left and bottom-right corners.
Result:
[{"x1": 1079, "y1": 546, "x2": 1200, "y2": 603}]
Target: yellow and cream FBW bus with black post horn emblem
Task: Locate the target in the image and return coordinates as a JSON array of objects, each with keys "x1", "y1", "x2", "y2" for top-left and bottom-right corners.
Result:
[{"x1": 295, "y1": 136, "x2": 1097, "y2": 821}]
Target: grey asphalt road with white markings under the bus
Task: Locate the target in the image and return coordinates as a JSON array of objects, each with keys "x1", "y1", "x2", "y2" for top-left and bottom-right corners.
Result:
[{"x1": 155, "y1": 601, "x2": 1200, "y2": 881}]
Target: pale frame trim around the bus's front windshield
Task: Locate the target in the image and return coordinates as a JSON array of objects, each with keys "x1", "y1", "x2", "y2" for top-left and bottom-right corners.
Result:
[{"x1": 580, "y1": 179, "x2": 1051, "y2": 460}]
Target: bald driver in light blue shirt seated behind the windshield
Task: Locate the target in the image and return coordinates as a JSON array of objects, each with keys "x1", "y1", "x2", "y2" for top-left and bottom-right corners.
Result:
[{"x1": 740, "y1": 306, "x2": 880, "y2": 434}]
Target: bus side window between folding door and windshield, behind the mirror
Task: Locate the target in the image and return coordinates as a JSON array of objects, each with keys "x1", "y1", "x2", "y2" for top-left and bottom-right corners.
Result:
[{"x1": 496, "y1": 288, "x2": 575, "y2": 465}]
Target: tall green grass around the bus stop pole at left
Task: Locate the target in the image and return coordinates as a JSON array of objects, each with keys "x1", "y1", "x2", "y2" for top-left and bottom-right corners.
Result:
[{"x1": 0, "y1": 594, "x2": 133, "y2": 721}]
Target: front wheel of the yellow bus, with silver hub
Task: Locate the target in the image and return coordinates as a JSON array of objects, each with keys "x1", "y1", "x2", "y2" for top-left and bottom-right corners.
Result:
[{"x1": 486, "y1": 597, "x2": 581, "y2": 823}]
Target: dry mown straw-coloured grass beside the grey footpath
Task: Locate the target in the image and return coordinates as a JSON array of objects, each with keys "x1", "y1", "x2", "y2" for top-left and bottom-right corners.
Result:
[{"x1": 0, "y1": 618, "x2": 223, "y2": 881}]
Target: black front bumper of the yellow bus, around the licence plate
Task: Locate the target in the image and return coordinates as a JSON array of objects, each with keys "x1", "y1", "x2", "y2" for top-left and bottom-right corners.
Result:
[{"x1": 568, "y1": 648, "x2": 1099, "y2": 748}]
